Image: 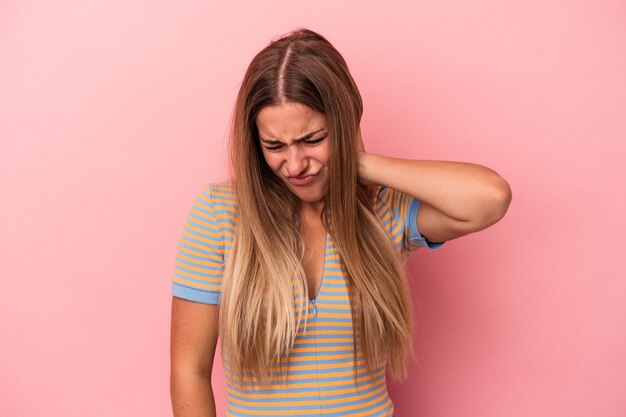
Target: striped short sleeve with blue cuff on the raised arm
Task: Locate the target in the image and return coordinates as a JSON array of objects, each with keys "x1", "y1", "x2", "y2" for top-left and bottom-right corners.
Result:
[{"x1": 372, "y1": 187, "x2": 444, "y2": 257}]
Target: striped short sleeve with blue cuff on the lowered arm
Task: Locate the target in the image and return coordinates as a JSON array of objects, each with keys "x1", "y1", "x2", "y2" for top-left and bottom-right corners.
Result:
[{"x1": 172, "y1": 185, "x2": 234, "y2": 304}]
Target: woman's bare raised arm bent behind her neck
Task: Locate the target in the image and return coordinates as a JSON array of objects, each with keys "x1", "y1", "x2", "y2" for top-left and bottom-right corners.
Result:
[{"x1": 359, "y1": 151, "x2": 511, "y2": 242}]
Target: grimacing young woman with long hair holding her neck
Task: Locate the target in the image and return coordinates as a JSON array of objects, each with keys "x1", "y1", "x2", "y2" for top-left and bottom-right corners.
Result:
[{"x1": 171, "y1": 29, "x2": 511, "y2": 417}]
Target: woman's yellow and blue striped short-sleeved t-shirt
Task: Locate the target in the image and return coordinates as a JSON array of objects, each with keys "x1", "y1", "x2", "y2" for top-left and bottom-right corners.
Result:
[{"x1": 172, "y1": 183, "x2": 441, "y2": 416}]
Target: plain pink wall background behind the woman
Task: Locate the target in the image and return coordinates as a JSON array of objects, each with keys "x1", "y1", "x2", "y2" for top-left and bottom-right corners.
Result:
[{"x1": 0, "y1": 0, "x2": 626, "y2": 417}]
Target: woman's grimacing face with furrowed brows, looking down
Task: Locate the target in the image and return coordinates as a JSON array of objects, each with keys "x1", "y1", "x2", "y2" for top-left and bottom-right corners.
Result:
[{"x1": 256, "y1": 102, "x2": 330, "y2": 208}]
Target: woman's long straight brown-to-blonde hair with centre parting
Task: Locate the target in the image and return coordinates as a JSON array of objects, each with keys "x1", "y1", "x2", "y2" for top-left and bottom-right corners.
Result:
[{"x1": 219, "y1": 29, "x2": 412, "y2": 386}]
